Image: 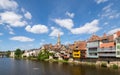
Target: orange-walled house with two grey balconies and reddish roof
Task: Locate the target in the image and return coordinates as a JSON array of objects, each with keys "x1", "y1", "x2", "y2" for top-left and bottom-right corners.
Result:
[{"x1": 98, "y1": 34, "x2": 116, "y2": 58}]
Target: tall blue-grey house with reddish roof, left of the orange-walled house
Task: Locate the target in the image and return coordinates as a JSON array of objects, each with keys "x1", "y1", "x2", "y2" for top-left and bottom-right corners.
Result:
[{"x1": 87, "y1": 35, "x2": 100, "y2": 58}]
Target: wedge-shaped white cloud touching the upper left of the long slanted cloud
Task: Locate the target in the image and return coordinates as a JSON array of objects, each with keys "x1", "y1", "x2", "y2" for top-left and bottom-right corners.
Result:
[{"x1": 54, "y1": 19, "x2": 74, "y2": 30}]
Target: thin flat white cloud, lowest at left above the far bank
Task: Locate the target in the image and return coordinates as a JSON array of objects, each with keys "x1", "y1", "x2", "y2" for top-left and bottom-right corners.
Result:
[{"x1": 10, "y1": 36, "x2": 34, "y2": 42}]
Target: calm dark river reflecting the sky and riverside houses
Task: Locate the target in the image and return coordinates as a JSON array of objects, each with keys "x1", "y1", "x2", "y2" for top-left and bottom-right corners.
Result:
[{"x1": 0, "y1": 58, "x2": 120, "y2": 75}]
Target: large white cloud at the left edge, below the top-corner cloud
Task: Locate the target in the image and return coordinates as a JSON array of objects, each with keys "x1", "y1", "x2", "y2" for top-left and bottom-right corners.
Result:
[{"x1": 0, "y1": 11, "x2": 27, "y2": 27}]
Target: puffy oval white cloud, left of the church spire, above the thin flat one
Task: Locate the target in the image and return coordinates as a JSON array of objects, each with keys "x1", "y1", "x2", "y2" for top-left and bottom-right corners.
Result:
[{"x1": 25, "y1": 24, "x2": 48, "y2": 34}]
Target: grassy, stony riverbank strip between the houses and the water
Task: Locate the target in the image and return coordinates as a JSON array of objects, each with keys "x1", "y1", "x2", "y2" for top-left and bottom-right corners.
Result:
[{"x1": 18, "y1": 58, "x2": 120, "y2": 69}]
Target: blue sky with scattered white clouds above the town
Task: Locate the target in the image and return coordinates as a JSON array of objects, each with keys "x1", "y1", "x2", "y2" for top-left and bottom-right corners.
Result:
[{"x1": 0, "y1": 0, "x2": 120, "y2": 51}]
